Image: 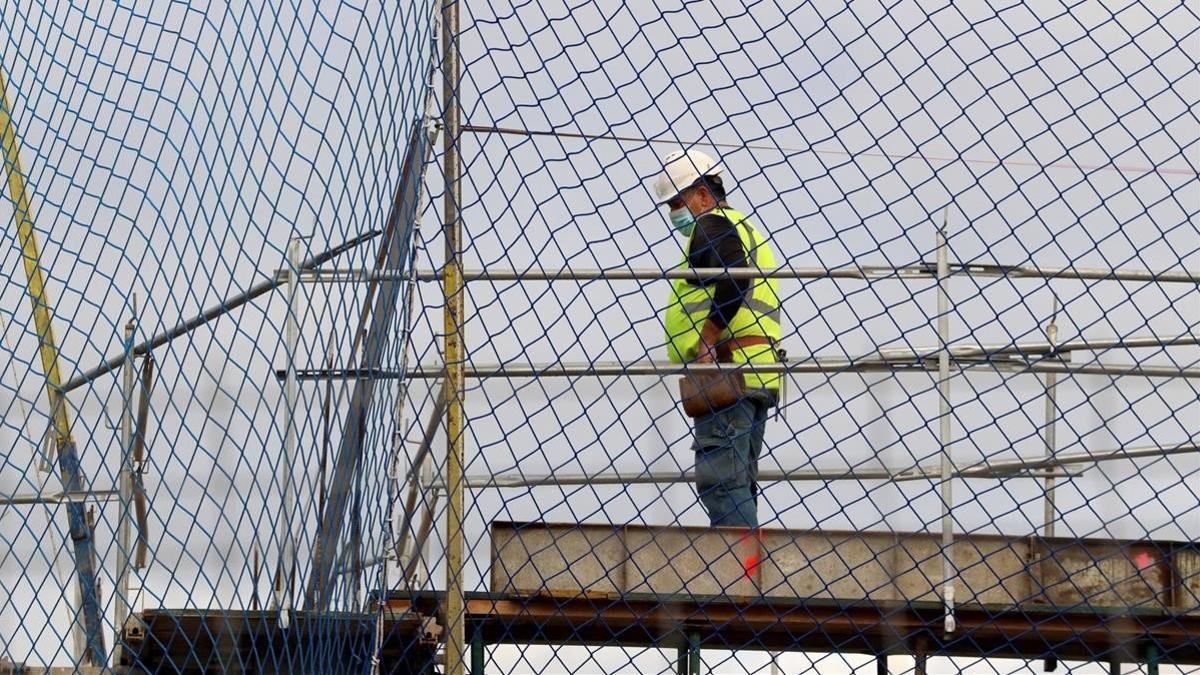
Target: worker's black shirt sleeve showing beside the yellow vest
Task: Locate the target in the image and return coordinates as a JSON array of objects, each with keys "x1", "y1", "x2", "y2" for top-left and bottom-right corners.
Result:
[{"x1": 688, "y1": 208, "x2": 750, "y2": 328}]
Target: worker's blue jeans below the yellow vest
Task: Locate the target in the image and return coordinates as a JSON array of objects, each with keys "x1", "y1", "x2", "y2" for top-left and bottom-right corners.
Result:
[{"x1": 692, "y1": 389, "x2": 778, "y2": 527}]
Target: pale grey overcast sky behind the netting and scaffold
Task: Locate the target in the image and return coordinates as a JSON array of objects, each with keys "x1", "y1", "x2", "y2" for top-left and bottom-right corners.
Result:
[{"x1": 0, "y1": 0, "x2": 1200, "y2": 673}]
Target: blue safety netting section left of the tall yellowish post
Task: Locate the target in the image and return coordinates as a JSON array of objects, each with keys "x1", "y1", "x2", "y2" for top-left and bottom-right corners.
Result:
[{"x1": 0, "y1": 0, "x2": 436, "y2": 673}]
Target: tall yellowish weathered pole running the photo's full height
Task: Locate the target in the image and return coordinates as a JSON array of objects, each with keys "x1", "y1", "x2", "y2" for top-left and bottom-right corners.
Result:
[{"x1": 442, "y1": 0, "x2": 466, "y2": 675}]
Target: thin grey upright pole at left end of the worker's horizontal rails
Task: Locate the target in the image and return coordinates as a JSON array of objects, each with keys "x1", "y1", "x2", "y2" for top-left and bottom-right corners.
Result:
[{"x1": 275, "y1": 238, "x2": 300, "y2": 631}]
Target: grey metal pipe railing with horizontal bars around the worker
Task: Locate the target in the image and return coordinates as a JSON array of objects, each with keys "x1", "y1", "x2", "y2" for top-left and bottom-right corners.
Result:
[{"x1": 276, "y1": 216, "x2": 1200, "y2": 651}]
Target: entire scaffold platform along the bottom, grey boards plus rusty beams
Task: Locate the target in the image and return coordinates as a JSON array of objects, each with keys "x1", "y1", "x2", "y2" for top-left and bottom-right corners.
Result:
[{"x1": 125, "y1": 522, "x2": 1200, "y2": 673}]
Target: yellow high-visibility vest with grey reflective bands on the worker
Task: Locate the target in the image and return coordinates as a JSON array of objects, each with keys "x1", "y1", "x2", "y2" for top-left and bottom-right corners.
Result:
[{"x1": 662, "y1": 208, "x2": 782, "y2": 389}]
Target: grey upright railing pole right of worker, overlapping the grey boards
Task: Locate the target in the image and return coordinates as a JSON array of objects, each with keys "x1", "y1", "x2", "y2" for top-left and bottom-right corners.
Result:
[{"x1": 937, "y1": 209, "x2": 954, "y2": 633}]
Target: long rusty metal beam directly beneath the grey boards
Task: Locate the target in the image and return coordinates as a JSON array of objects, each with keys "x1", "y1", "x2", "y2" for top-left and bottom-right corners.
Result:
[{"x1": 385, "y1": 591, "x2": 1200, "y2": 664}]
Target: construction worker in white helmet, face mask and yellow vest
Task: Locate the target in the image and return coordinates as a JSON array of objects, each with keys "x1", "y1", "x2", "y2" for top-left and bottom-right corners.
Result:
[{"x1": 654, "y1": 150, "x2": 782, "y2": 527}]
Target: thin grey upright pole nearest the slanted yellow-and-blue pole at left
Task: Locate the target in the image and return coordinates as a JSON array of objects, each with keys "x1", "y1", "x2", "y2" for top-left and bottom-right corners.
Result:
[{"x1": 113, "y1": 306, "x2": 138, "y2": 663}]
